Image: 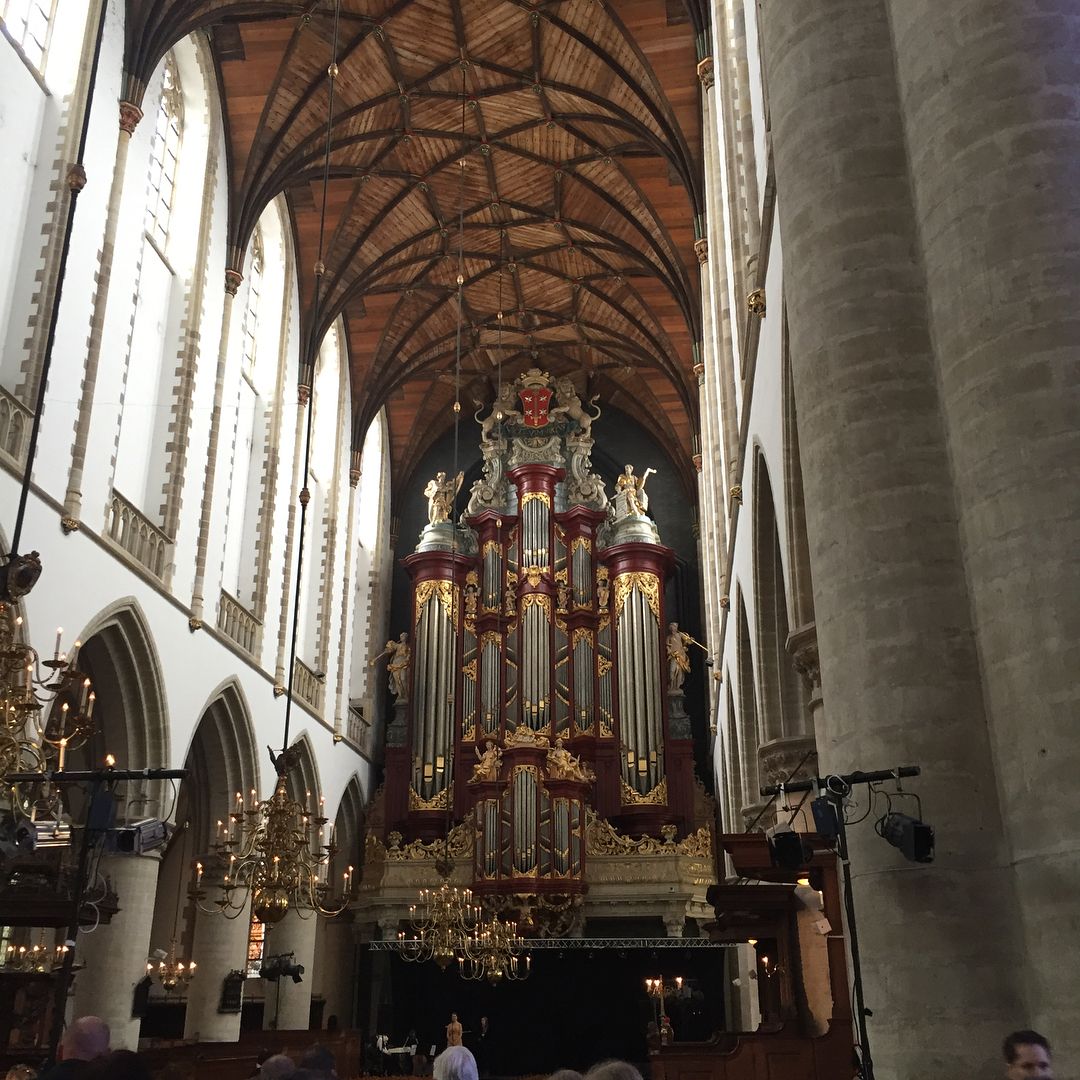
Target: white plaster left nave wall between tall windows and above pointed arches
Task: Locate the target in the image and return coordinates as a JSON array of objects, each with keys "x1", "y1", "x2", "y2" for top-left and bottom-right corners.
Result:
[{"x1": 0, "y1": 6, "x2": 377, "y2": 816}]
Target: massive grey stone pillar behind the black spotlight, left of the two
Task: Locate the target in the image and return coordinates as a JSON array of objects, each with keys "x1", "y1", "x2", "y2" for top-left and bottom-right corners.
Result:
[{"x1": 760, "y1": 0, "x2": 1021, "y2": 1080}]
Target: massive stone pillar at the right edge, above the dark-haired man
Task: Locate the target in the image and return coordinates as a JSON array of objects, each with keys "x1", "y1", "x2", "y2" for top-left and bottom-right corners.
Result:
[{"x1": 890, "y1": 0, "x2": 1080, "y2": 1054}]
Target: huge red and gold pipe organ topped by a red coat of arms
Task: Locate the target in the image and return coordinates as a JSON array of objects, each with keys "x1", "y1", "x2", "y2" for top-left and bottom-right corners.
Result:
[{"x1": 387, "y1": 369, "x2": 692, "y2": 911}]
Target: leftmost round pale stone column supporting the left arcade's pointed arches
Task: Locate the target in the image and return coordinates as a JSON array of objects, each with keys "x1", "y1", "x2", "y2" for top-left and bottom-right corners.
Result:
[{"x1": 73, "y1": 855, "x2": 161, "y2": 1050}]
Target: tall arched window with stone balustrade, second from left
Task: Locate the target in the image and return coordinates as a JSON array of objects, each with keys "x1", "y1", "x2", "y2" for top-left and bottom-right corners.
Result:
[{"x1": 112, "y1": 38, "x2": 213, "y2": 548}]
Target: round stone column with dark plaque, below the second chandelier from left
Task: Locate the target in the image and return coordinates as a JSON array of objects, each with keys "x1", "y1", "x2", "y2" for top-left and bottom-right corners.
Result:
[{"x1": 184, "y1": 905, "x2": 251, "y2": 1042}]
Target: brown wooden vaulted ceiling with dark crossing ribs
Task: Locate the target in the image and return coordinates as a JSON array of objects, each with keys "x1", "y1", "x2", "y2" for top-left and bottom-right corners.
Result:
[{"x1": 125, "y1": 0, "x2": 703, "y2": 491}]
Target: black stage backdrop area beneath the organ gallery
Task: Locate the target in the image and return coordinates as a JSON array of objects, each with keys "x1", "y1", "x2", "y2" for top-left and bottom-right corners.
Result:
[{"x1": 360, "y1": 948, "x2": 724, "y2": 1076}]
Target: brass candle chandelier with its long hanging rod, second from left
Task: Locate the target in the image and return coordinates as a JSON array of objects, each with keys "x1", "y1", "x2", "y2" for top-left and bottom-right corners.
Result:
[{"x1": 190, "y1": 0, "x2": 353, "y2": 924}]
